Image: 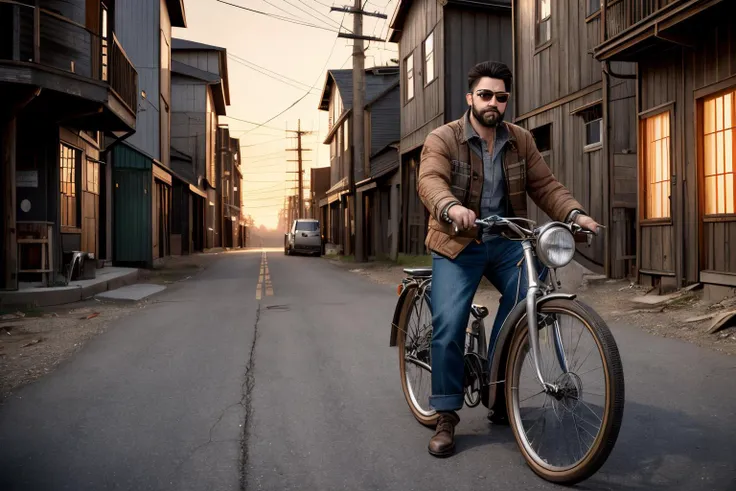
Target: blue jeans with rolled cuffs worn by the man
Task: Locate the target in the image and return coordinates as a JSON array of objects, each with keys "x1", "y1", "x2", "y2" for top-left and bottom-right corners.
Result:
[{"x1": 429, "y1": 237, "x2": 542, "y2": 411}]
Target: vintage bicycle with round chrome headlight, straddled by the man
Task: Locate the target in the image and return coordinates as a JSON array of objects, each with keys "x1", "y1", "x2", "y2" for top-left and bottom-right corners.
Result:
[{"x1": 389, "y1": 216, "x2": 624, "y2": 485}]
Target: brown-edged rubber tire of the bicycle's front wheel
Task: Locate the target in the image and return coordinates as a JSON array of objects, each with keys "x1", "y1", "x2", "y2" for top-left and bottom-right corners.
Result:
[{"x1": 504, "y1": 300, "x2": 625, "y2": 486}]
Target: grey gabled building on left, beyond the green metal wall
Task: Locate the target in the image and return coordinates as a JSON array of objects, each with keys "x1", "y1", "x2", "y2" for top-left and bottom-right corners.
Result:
[{"x1": 170, "y1": 38, "x2": 231, "y2": 254}]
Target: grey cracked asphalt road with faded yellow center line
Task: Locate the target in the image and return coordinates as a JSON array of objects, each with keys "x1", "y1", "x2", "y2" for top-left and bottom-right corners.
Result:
[{"x1": 0, "y1": 251, "x2": 736, "y2": 491}]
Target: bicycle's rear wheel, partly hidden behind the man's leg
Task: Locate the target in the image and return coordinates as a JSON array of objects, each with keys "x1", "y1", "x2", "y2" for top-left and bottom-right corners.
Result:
[{"x1": 396, "y1": 286, "x2": 439, "y2": 427}]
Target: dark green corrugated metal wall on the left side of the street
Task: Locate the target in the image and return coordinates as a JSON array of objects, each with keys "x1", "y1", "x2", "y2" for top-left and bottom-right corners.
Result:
[{"x1": 113, "y1": 145, "x2": 153, "y2": 266}]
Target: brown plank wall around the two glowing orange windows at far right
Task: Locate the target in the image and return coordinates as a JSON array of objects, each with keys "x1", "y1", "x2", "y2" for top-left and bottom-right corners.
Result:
[{"x1": 639, "y1": 6, "x2": 736, "y2": 282}]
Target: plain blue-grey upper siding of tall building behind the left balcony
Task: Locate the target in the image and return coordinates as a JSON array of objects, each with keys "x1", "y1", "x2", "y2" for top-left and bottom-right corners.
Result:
[{"x1": 115, "y1": 0, "x2": 161, "y2": 159}]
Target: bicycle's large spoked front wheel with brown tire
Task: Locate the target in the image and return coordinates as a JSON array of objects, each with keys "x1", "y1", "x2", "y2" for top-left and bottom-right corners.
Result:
[{"x1": 506, "y1": 300, "x2": 624, "y2": 485}]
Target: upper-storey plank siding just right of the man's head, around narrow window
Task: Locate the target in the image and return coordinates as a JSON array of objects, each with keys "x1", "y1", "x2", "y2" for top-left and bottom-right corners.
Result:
[{"x1": 514, "y1": 0, "x2": 602, "y2": 116}]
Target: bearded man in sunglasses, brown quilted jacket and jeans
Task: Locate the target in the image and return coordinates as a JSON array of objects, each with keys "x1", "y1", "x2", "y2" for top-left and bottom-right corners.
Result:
[{"x1": 417, "y1": 61, "x2": 598, "y2": 457}]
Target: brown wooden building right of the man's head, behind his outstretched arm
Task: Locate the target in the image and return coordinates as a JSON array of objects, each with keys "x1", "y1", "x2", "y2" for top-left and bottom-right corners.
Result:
[{"x1": 513, "y1": 0, "x2": 637, "y2": 278}]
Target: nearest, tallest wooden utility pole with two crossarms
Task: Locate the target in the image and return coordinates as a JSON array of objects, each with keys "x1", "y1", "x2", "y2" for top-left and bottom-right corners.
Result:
[{"x1": 330, "y1": 0, "x2": 387, "y2": 261}]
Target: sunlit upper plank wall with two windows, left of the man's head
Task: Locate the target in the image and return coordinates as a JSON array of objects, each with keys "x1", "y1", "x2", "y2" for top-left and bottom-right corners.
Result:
[{"x1": 399, "y1": 0, "x2": 445, "y2": 153}]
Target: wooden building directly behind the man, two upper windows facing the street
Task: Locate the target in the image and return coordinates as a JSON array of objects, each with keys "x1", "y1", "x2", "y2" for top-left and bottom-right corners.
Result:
[{"x1": 389, "y1": 0, "x2": 515, "y2": 254}]
